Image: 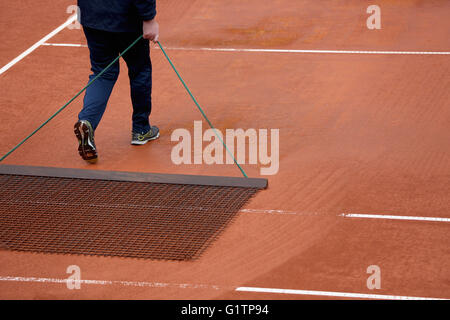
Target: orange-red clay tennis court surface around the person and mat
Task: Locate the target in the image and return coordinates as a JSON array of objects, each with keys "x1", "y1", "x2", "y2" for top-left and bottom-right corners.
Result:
[{"x1": 0, "y1": 0, "x2": 450, "y2": 299}]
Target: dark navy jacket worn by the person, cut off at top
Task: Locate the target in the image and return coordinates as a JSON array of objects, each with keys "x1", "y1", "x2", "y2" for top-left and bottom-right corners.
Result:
[{"x1": 78, "y1": 0, "x2": 156, "y2": 32}]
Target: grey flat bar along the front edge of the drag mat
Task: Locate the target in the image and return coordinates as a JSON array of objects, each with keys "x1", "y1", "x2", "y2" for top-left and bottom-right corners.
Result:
[{"x1": 0, "y1": 165, "x2": 268, "y2": 189}]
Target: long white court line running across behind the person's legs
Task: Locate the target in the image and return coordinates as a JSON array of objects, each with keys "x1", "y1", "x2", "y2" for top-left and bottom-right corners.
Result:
[{"x1": 44, "y1": 43, "x2": 450, "y2": 55}]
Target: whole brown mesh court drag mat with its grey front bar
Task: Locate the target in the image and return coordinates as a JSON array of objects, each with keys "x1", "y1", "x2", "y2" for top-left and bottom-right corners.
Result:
[{"x1": 0, "y1": 165, "x2": 267, "y2": 260}]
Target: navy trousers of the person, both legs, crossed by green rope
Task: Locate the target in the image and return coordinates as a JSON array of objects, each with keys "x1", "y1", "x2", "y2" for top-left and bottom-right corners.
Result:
[{"x1": 78, "y1": 27, "x2": 152, "y2": 134}]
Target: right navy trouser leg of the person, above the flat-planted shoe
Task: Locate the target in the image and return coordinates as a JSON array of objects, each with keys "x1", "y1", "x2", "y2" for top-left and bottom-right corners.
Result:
[{"x1": 119, "y1": 33, "x2": 152, "y2": 134}]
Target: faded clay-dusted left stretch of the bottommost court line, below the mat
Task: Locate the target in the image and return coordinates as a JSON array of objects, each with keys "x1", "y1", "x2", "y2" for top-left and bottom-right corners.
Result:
[{"x1": 0, "y1": 276, "x2": 220, "y2": 290}]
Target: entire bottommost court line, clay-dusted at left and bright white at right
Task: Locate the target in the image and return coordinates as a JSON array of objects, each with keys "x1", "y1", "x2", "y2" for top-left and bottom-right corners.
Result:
[{"x1": 0, "y1": 276, "x2": 446, "y2": 300}]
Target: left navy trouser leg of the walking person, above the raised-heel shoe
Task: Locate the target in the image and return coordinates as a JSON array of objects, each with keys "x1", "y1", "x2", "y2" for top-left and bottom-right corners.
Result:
[{"x1": 78, "y1": 27, "x2": 119, "y2": 130}]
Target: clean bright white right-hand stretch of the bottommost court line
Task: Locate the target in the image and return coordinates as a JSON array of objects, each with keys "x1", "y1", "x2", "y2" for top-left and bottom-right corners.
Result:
[{"x1": 235, "y1": 287, "x2": 447, "y2": 300}]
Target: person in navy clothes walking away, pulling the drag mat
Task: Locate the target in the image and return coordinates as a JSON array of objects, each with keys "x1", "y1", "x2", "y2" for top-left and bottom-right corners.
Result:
[{"x1": 74, "y1": 0, "x2": 159, "y2": 163}]
